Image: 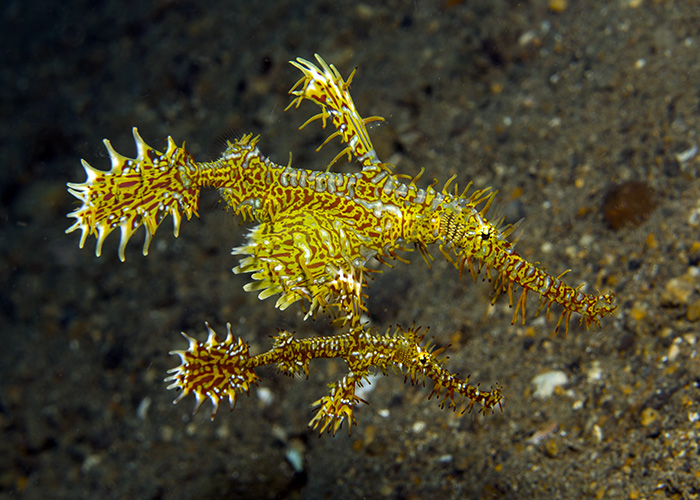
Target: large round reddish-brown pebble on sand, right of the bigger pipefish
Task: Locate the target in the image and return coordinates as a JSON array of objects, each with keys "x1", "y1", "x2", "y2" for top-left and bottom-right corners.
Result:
[{"x1": 603, "y1": 181, "x2": 656, "y2": 231}]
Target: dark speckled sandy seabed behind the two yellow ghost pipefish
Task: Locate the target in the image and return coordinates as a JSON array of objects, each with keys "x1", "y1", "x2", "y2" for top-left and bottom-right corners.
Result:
[{"x1": 0, "y1": 0, "x2": 700, "y2": 499}]
